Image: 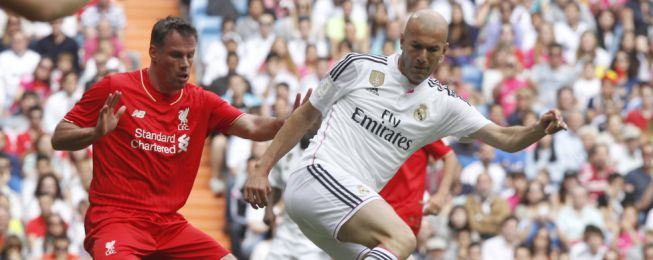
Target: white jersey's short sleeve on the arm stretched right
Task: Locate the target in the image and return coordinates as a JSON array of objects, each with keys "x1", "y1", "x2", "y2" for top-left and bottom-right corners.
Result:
[{"x1": 444, "y1": 92, "x2": 491, "y2": 138}]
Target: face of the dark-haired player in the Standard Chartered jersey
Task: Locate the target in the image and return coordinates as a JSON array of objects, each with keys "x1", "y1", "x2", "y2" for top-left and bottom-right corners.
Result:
[{"x1": 150, "y1": 31, "x2": 197, "y2": 90}]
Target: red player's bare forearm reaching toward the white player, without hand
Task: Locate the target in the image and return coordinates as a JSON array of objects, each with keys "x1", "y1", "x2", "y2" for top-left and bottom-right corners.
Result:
[{"x1": 227, "y1": 114, "x2": 284, "y2": 142}]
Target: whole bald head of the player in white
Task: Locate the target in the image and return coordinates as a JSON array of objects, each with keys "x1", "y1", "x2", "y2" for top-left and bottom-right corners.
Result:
[{"x1": 399, "y1": 10, "x2": 449, "y2": 85}]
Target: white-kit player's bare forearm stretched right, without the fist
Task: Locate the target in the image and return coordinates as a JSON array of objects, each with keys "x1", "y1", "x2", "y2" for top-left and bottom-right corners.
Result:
[{"x1": 471, "y1": 123, "x2": 546, "y2": 153}]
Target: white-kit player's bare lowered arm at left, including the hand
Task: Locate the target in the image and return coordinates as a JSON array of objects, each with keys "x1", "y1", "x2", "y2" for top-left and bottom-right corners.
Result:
[{"x1": 244, "y1": 102, "x2": 322, "y2": 208}]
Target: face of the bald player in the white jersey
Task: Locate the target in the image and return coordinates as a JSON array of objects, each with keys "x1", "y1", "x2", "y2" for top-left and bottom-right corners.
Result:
[{"x1": 401, "y1": 26, "x2": 448, "y2": 84}]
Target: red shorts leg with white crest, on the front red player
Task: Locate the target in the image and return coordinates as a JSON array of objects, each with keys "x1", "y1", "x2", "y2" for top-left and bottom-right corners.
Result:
[{"x1": 85, "y1": 222, "x2": 156, "y2": 259}]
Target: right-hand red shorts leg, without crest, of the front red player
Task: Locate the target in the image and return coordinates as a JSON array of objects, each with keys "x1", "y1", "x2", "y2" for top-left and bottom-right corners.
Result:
[{"x1": 157, "y1": 223, "x2": 229, "y2": 259}]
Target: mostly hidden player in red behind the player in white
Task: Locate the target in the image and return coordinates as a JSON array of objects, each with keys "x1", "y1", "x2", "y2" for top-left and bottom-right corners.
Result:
[{"x1": 379, "y1": 140, "x2": 460, "y2": 236}]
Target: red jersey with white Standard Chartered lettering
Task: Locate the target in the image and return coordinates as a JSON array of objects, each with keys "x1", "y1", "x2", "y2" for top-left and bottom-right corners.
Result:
[{"x1": 64, "y1": 69, "x2": 242, "y2": 213}]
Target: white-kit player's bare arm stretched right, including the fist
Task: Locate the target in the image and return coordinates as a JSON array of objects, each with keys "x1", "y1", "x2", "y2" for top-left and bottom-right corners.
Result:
[{"x1": 471, "y1": 110, "x2": 567, "y2": 153}]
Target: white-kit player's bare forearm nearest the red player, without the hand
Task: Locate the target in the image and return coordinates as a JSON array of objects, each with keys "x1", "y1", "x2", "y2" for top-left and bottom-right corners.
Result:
[{"x1": 258, "y1": 102, "x2": 322, "y2": 174}]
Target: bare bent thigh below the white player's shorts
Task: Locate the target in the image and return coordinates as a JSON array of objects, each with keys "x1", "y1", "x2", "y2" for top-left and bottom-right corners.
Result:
[{"x1": 338, "y1": 200, "x2": 412, "y2": 248}]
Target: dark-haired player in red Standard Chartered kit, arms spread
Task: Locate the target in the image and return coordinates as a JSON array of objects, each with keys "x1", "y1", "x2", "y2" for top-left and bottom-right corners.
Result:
[{"x1": 52, "y1": 17, "x2": 294, "y2": 259}]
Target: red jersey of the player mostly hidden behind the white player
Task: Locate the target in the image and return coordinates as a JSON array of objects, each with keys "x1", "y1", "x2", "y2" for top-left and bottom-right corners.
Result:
[{"x1": 379, "y1": 140, "x2": 451, "y2": 234}]
